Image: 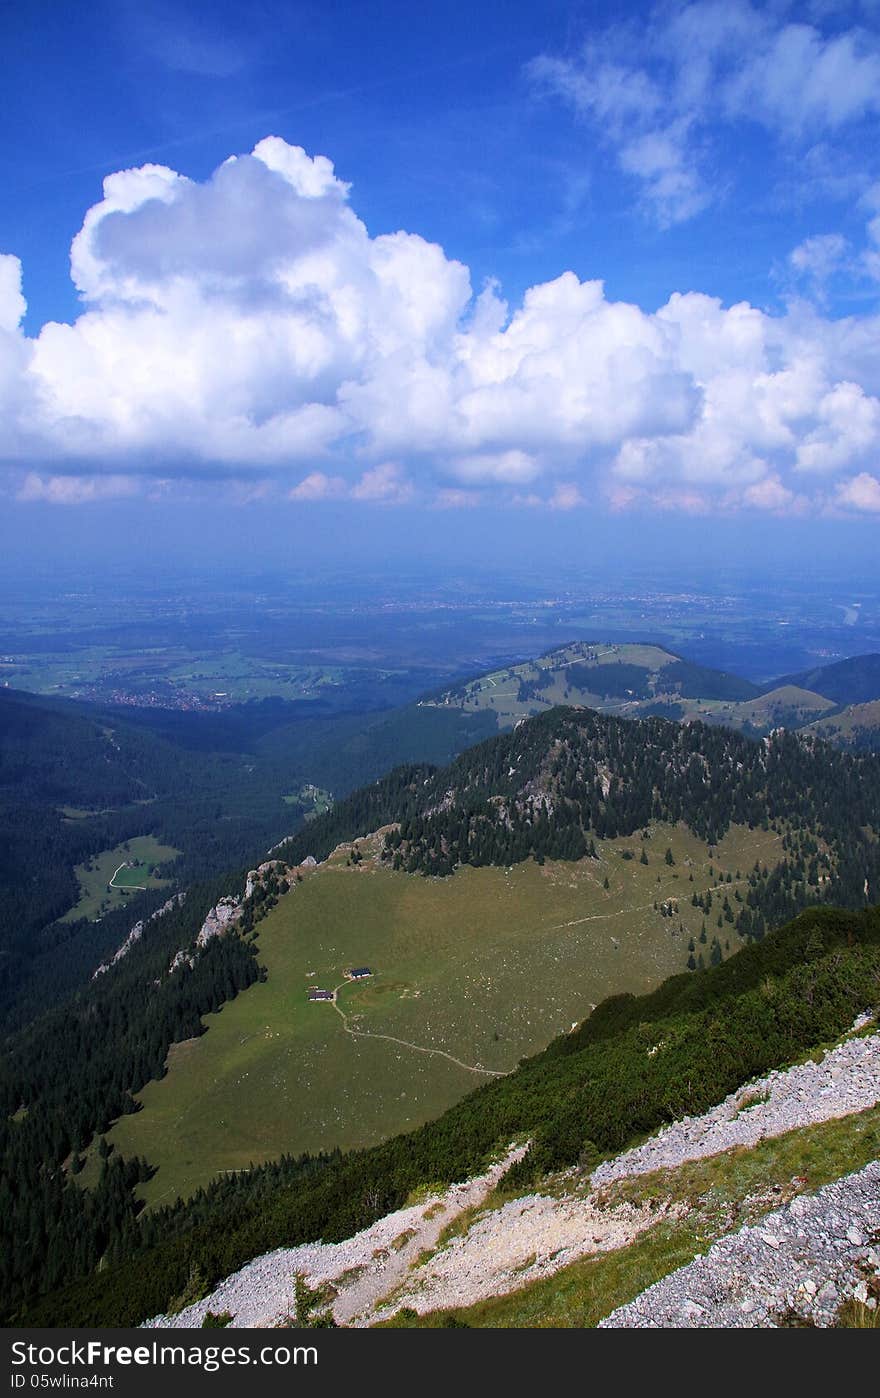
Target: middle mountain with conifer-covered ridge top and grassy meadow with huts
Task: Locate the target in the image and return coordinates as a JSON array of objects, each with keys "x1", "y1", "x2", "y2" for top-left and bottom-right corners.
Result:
[{"x1": 104, "y1": 709, "x2": 880, "y2": 1204}]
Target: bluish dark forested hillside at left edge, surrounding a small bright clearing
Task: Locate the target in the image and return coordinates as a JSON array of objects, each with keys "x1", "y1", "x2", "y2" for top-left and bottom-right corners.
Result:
[{"x1": 0, "y1": 691, "x2": 292, "y2": 1025}]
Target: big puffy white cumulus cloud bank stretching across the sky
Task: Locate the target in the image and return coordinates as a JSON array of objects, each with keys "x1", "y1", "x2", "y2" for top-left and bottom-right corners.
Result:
[{"x1": 0, "y1": 128, "x2": 880, "y2": 513}]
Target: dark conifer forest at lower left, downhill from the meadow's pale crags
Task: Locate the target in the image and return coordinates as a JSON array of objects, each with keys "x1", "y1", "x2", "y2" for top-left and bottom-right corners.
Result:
[{"x1": 0, "y1": 879, "x2": 260, "y2": 1316}]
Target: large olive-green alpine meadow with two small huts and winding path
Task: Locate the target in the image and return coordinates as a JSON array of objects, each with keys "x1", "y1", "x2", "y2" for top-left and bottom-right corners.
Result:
[{"x1": 104, "y1": 826, "x2": 779, "y2": 1204}]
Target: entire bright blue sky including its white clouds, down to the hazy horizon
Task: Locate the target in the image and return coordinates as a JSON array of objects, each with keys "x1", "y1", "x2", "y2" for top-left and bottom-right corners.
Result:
[{"x1": 0, "y1": 0, "x2": 880, "y2": 567}]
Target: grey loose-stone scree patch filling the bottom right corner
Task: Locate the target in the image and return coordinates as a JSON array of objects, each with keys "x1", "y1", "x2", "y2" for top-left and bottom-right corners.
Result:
[{"x1": 600, "y1": 1160, "x2": 880, "y2": 1329}]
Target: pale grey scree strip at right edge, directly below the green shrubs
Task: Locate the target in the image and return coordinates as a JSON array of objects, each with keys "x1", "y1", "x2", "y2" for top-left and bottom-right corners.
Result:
[{"x1": 590, "y1": 1016, "x2": 880, "y2": 1188}]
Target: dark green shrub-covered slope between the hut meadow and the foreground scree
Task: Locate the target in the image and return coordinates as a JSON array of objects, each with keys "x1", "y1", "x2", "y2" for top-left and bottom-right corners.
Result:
[{"x1": 20, "y1": 909, "x2": 880, "y2": 1325}]
